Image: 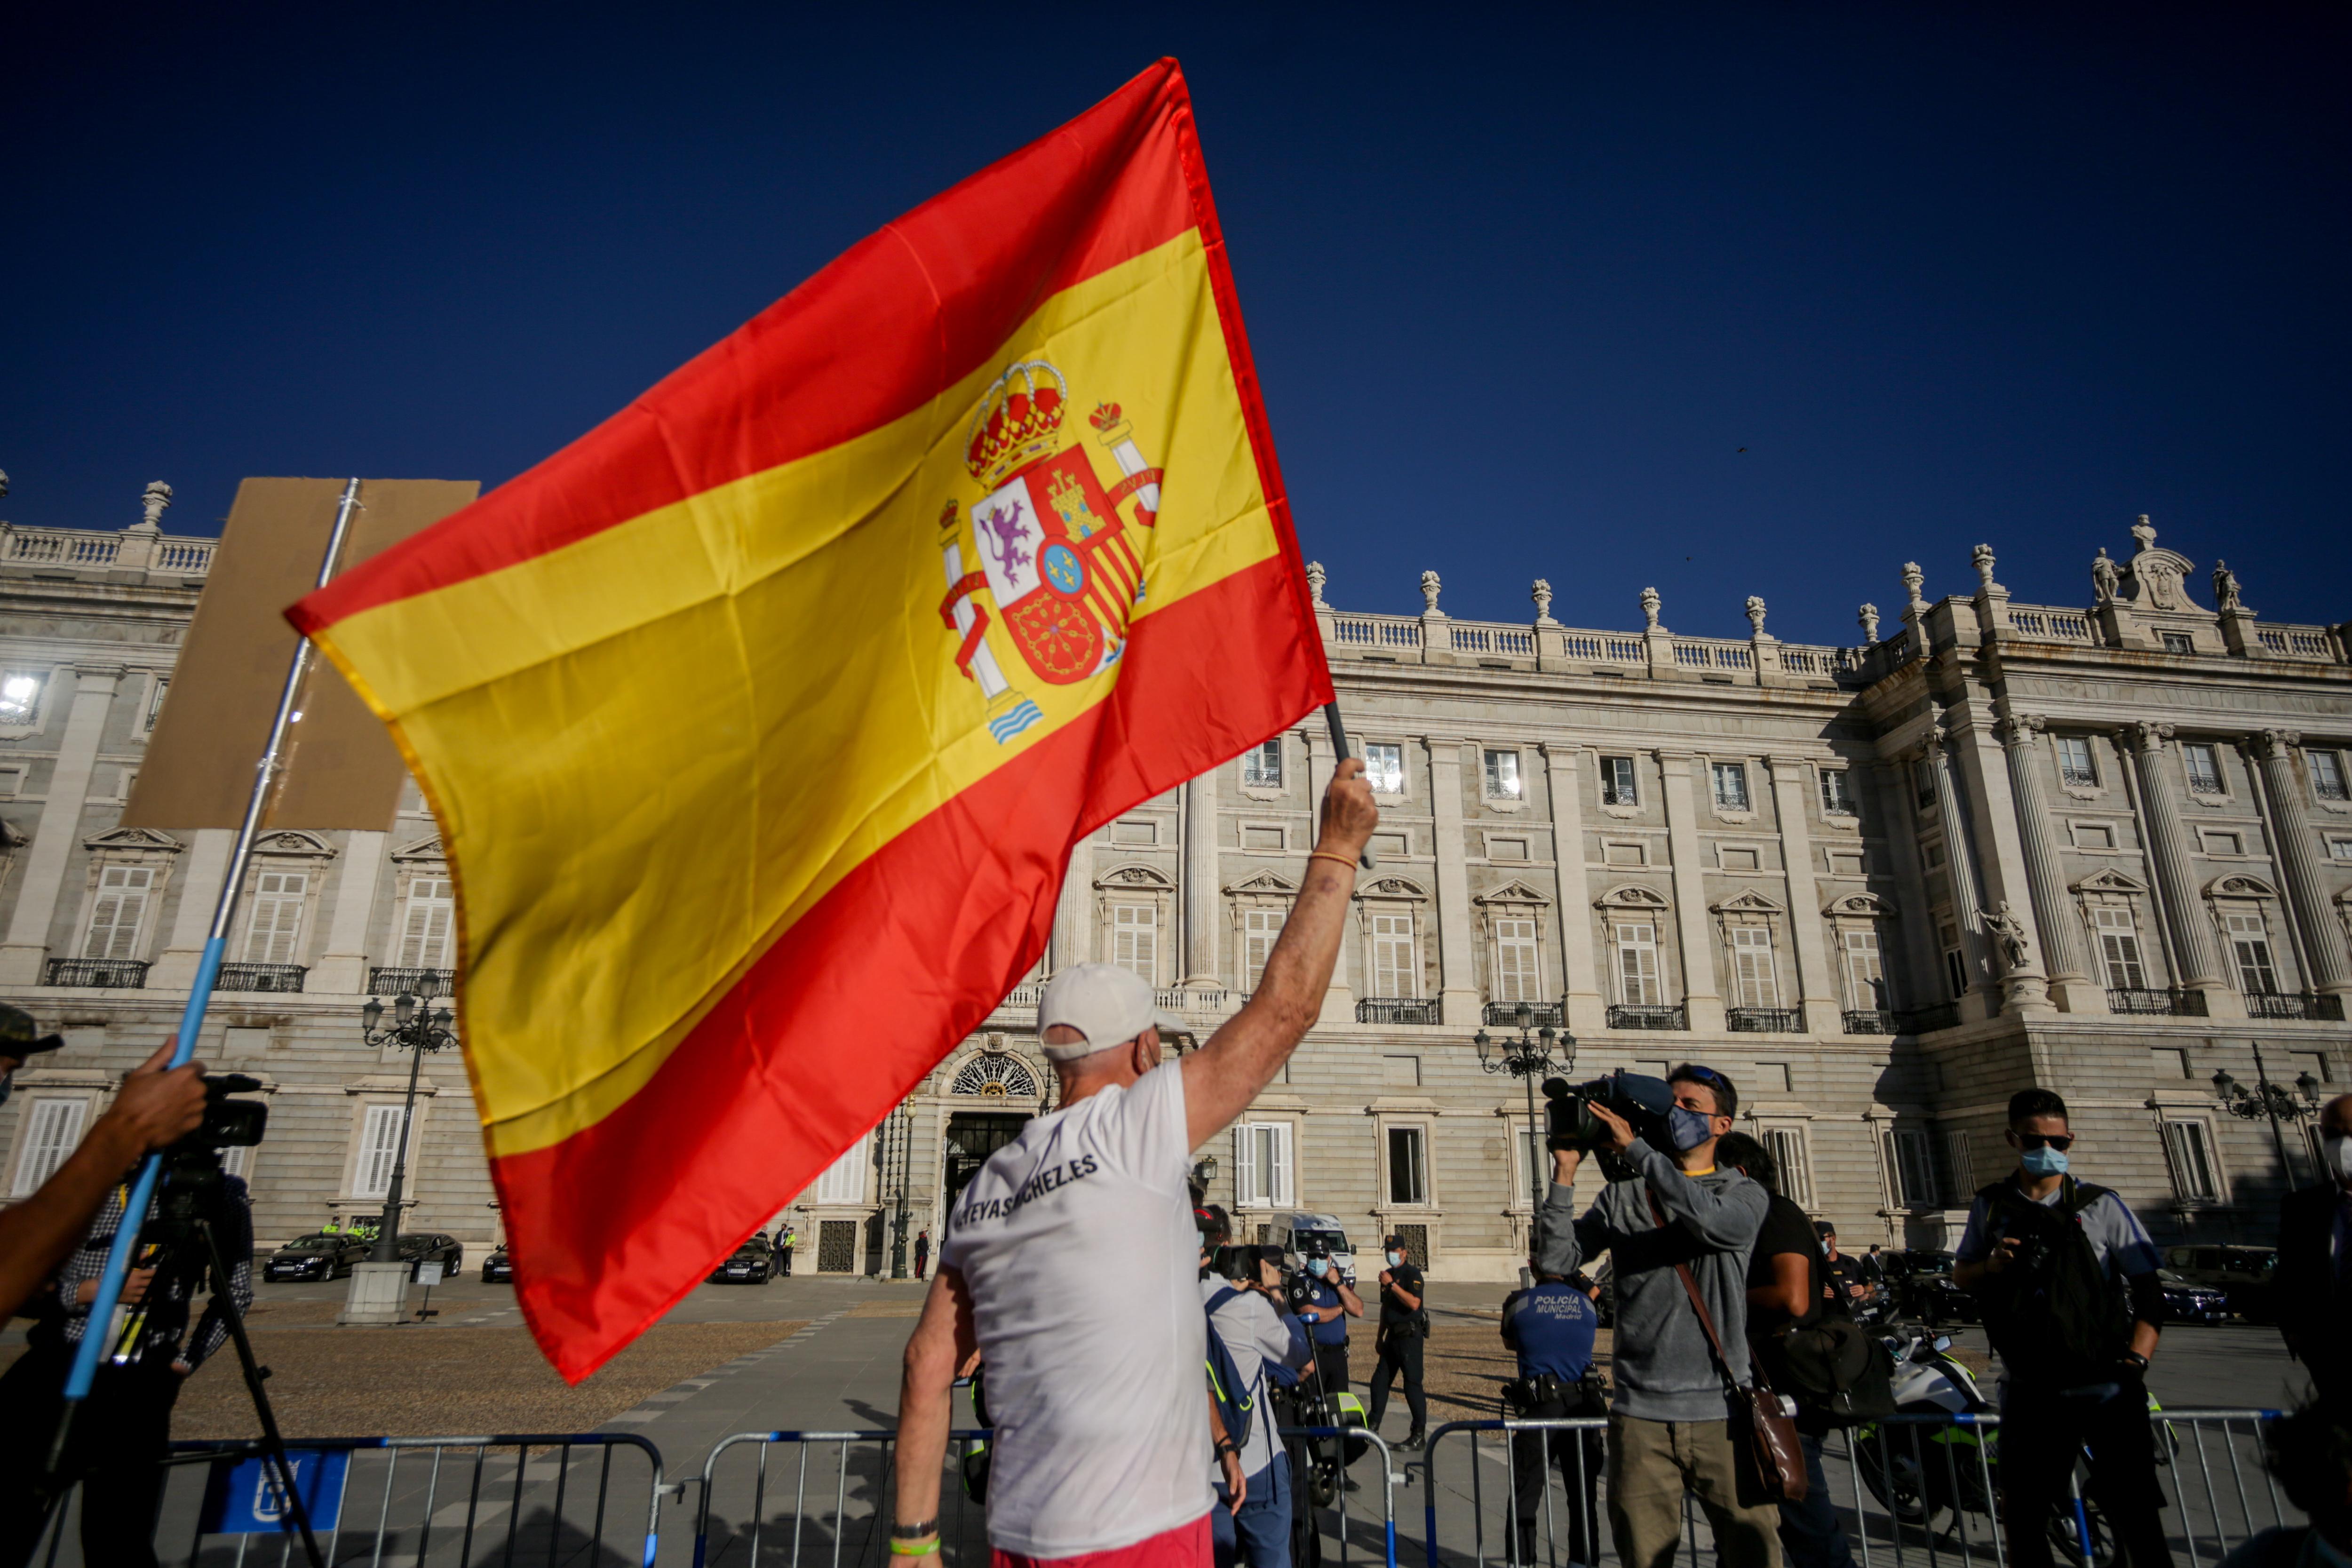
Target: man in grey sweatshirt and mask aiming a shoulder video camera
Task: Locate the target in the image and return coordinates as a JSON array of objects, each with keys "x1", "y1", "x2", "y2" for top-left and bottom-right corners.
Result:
[{"x1": 1541, "y1": 1063, "x2": 1780, "y2": 1568}]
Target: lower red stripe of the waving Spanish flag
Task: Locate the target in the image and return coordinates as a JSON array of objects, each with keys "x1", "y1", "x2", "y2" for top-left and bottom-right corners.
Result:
[{"x1": 492, "y1": 557, "x2": 1331, "y2": 1382}]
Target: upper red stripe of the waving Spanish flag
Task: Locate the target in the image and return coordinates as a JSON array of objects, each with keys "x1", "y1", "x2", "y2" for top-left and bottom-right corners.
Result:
[{"x1": 287, "y1": 59, "x2": 1204, "y2": 632}]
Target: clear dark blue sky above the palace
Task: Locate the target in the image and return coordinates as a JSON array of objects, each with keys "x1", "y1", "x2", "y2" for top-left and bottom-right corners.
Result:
[{"x1": 0, "y1": 2, "x2": 2352, "y2": 642}]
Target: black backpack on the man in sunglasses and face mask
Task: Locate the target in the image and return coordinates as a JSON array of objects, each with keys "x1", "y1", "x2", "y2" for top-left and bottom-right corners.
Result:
[{"x1": 1976, "y1": 1176, "x2": 2131, "y2": 1387}]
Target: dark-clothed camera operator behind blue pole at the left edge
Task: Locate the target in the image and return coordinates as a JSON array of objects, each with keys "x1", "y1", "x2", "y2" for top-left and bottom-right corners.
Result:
[{"x1": 0, "y1": 1063, "x2": 263, "y2": 1568}]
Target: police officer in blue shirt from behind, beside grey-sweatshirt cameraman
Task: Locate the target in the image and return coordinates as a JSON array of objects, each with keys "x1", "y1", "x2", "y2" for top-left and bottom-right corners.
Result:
[{"x1": 1503, "y1": 1258, "x2": 1609, "y2": 1563}]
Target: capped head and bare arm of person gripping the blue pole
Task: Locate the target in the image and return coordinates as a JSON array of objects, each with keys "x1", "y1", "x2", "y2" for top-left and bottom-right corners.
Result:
[{"x1": 0, "y1": 1034, "x2": 205, "y2": 1321}]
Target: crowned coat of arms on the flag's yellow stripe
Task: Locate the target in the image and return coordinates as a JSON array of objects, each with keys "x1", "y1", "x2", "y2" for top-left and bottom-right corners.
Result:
[{"x1": 938, "y1": 360, "x2": 1160, "y2": 745}]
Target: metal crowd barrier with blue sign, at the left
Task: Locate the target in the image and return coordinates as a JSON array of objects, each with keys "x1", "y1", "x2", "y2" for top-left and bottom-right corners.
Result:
[{"x1": 33, "y1": 1432, "x2": 666, "y2": 1568}]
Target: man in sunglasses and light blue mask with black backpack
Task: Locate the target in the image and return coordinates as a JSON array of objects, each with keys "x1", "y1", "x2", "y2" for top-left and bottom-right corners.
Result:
[{"x1": 1952, "y1": 1089, "x2": 2173, "y2": 1568}]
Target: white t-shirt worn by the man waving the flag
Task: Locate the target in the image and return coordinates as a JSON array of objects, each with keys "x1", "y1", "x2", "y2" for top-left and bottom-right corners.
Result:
[{"x1": 938, "y1": 1063, "x2": 1211, "y2": 1556}]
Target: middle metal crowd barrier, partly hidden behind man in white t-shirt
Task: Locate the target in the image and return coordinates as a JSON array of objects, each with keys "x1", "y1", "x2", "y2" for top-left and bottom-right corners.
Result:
[{"x1": 694, "y1": 1427, "x2": 1397, "y2": 1568}]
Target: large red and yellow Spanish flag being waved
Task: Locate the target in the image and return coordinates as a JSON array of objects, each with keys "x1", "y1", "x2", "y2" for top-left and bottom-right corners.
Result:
[{"x1": 287, "y1": 61, "x2": 1331, "y2": 1382}]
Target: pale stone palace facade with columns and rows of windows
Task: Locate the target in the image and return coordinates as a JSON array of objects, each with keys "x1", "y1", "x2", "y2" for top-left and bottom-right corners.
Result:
[{"x1": 0, "y1": 486, "x2": 2352, "y2": 1279}]
